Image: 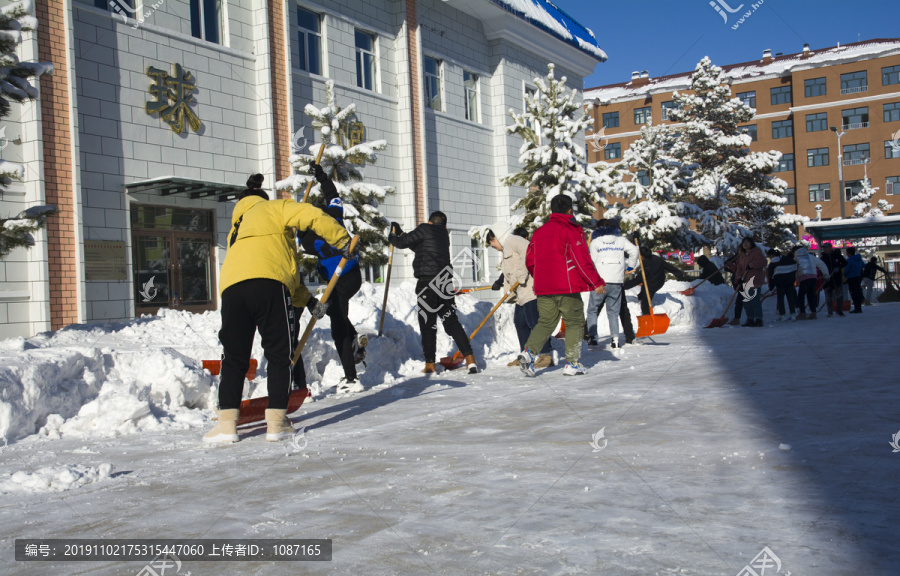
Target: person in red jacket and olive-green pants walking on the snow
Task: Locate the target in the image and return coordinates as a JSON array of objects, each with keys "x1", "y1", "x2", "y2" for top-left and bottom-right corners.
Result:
[{"x1": 518, "y1": 194, "x2": 606, "y2": 376}]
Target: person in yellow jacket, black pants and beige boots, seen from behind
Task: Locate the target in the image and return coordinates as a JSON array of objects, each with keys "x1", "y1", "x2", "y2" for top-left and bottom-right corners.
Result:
[{"x1": 203, "y1": 174, "x2": 350, "y2": 442}]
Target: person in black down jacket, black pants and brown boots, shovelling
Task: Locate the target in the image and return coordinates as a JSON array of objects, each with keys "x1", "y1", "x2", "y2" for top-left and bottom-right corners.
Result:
[{"x1": 388, "y1": 212, "x2": 478, "y2": 374}]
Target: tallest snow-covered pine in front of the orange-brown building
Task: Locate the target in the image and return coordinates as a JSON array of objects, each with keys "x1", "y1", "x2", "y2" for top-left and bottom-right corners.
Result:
[{"x1": 668, "y1": 58, "x2": 806, "y2": 254}]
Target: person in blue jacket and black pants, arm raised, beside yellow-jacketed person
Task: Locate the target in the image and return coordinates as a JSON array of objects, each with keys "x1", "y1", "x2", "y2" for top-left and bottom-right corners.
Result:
[{"x1": 297, "y1": 162, "x2": 368, "y2": 394}]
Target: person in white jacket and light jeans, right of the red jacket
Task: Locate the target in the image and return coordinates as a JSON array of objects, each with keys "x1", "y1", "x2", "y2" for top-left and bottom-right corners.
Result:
[{"x1": 586, "y1": 219, "x2": 638, "y2": 348}]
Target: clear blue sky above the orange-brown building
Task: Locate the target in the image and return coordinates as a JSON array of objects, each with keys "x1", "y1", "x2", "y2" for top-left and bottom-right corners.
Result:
[{"x1": 551, "y1": 0, "x2": 900, "y2": 88}]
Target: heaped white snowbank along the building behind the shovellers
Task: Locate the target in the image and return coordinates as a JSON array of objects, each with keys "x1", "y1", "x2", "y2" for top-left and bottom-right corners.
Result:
[{"x1": 0, "y1": 281, "x2": 740, "y2": 442}]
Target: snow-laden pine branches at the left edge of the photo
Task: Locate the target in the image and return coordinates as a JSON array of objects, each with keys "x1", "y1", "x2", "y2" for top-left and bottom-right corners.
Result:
[{"x1": 0, "y1": 0, "x2": 56, "y2": 258}]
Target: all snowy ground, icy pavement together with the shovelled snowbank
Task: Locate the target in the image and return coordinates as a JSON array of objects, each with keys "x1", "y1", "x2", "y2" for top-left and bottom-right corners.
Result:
[{"x1": 0, "y1": 282, "x2": 900, "y2": 576}]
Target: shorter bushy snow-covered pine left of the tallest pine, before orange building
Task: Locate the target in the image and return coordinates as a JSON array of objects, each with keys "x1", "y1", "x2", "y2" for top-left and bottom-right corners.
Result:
[{"x1": 597, "y1": 124, "x2": 706, "y2": 251}]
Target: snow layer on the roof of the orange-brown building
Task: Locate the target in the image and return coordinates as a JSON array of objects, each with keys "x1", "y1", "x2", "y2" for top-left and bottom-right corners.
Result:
[{"x1": 584, "y1": 38, "x2": 900, "y2": 103}]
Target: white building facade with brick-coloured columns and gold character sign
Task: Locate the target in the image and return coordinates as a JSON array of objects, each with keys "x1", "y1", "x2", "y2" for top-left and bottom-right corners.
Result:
[{"x1": 0, "y1": 0, "x2": 605, "y2": 338}]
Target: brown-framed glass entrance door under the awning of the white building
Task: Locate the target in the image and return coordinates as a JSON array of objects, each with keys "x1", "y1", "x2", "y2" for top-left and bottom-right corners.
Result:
[{"x1": 131, "y1": 206, "x2": 216, "y2": 315}]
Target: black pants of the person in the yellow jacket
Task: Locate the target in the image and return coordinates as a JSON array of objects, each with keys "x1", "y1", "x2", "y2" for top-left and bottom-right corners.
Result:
[{"x1": 219, "y1": 278, "x2": 293, "y2": 410}]
